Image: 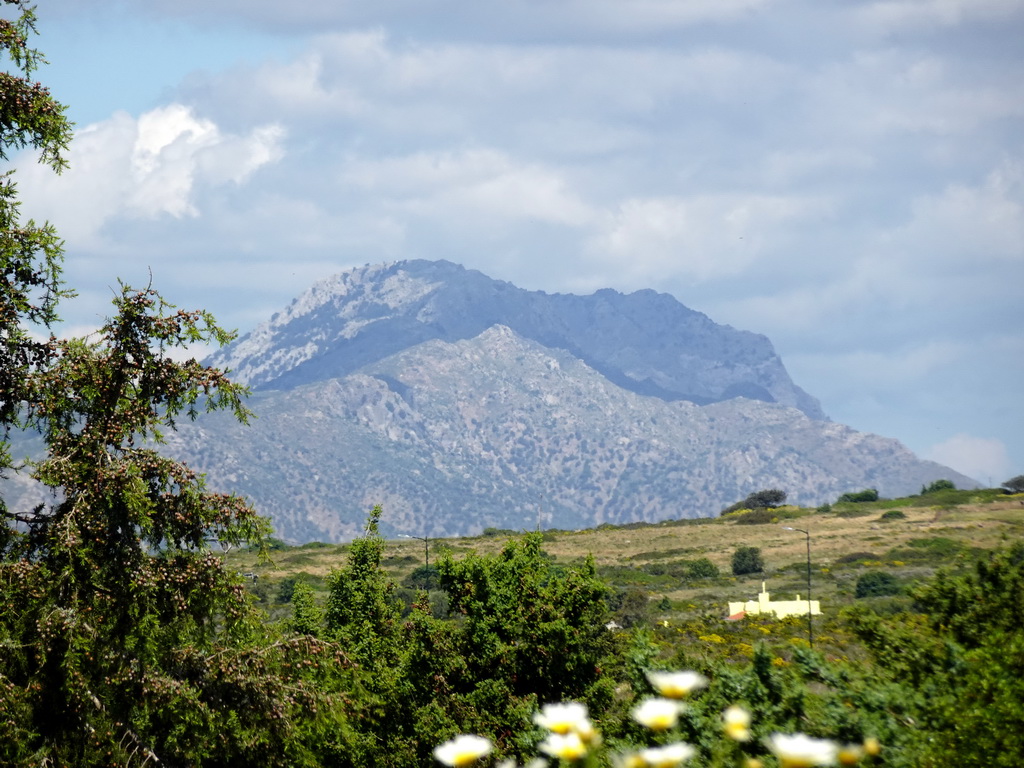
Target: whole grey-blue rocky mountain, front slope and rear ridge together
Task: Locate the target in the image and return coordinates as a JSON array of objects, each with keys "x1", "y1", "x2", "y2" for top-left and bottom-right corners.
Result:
[{"x1": 148, "y1": 261, "x2": 973, "y2": 542}]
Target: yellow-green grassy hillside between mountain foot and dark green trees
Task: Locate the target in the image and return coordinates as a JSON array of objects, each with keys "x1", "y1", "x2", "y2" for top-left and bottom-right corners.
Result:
[{"x1": 229, "y1": 489, "x2": 1024, "y2": 638}]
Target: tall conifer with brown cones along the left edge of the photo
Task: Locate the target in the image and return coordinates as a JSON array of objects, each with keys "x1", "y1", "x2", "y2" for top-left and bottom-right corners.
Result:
[{"x1": 0, "y1": 7, "x2": 337, "y2": 766}]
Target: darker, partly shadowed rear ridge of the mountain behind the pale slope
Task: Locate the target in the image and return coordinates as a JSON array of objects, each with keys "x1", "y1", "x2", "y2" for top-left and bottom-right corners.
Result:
[{"x1": 210, "y1": 261, "x2": 825, "y2": 419}]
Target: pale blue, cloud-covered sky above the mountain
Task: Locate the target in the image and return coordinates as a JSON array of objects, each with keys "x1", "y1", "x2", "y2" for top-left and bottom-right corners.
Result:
[{"x1": 9, "y1": 0, "x2": 1024, "y2": 485}]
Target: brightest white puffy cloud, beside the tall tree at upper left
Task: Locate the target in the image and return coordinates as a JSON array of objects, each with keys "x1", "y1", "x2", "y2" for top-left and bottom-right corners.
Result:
[{"x1": 18, "y1": 103, "x2": 284, "y2": 246}]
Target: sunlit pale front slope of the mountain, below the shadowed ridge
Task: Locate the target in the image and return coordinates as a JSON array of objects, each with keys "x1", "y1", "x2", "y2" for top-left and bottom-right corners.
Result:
[{"x1": 172, "y1": 326, "x2": 971, "y2": 542}]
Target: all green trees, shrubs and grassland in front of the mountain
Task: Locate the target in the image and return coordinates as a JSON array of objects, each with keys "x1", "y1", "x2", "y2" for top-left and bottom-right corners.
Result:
[{"x1": 0, "y1": 9, "x2": 1024, "y2": 768}]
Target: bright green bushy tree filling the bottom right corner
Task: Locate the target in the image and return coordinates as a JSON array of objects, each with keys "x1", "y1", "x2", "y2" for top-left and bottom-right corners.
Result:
[{"x1": 853, "y1": 544, "x2": 1024, "y2": 768}]
